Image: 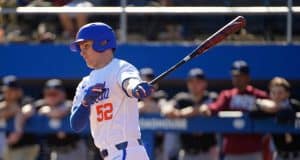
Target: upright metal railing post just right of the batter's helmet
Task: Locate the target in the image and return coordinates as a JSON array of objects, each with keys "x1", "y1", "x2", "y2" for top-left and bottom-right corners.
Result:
[{"x1": 120, "y1": 0, "x2": 127, "y2": 43}]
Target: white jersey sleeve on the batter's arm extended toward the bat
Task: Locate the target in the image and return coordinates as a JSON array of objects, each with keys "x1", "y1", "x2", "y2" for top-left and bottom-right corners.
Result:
[{"x1": 117, "y1": 62, "x2": 141, "y2": 87}]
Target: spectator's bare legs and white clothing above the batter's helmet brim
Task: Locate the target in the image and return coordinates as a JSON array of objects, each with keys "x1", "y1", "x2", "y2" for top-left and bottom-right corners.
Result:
[{"x1": 59, "y1": 0, "x2": 93, "y2": 39}]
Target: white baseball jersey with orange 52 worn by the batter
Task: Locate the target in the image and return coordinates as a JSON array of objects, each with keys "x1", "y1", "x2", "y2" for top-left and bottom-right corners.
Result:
[{"x1": 73, "y1": 58, "x2": 141, "y2": 148}]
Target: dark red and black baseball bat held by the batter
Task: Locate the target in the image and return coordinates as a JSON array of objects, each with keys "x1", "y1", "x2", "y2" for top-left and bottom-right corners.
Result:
[{"x1": 150, "y1": 16, "x2": 246, "y2": 85}]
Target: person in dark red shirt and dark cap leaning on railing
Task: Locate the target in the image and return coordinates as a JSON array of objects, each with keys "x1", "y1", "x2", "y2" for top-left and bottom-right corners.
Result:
[{"x1": 180, "y1": 60, "x2": 276, "y2": 160}]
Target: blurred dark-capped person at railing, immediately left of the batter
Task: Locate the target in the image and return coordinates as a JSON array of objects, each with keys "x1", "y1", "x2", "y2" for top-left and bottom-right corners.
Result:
[{"x1": 35, "y1": 79, "x2": 87, "y2": 160}]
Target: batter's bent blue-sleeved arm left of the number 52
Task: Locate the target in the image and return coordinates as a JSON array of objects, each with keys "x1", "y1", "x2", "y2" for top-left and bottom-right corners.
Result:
[{"x1": 70, "y1": 105, "x2": 90, "y2": 132}]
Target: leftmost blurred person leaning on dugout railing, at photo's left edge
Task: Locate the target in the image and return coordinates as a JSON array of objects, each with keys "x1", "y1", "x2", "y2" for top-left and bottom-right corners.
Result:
[{"x1": 0, "y1": 76, "x2": 39, "y2": 160}]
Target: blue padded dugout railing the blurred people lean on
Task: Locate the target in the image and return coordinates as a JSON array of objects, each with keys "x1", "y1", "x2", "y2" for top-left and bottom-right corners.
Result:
[{"x1": 0, "y1": 111, "x2": 300, "y2": 159}]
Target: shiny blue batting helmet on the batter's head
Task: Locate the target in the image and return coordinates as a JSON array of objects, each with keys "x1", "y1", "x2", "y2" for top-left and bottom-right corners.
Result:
[{"x1": 70, "y1": 22, "x2": 117, "y2": 52}]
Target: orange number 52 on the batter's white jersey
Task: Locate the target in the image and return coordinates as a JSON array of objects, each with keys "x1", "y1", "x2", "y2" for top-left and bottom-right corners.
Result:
[{"x1": 96, "y1": 103, "x2": 113, "y2": 122}]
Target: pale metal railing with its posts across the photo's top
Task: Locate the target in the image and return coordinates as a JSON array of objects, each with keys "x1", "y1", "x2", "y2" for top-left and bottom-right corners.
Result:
[{"x1": 0, "y1": 0, "x2": 300, "y2": 43}]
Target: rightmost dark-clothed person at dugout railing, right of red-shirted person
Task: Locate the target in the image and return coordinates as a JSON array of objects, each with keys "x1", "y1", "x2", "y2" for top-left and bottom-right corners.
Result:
[{"x1": 269, "y1": 77, "x2": 300, "y2": 160}]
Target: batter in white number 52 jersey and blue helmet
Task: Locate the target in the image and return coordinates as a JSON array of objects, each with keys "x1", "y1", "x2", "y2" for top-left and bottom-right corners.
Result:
[{"x1": 70, "y1": 22, "x2": 153, "y2": 160}]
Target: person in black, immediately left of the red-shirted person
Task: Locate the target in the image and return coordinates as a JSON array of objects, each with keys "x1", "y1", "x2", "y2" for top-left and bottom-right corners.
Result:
[{"x1": 166, "y1": 68, "x2": 219, "y2": 160}]
